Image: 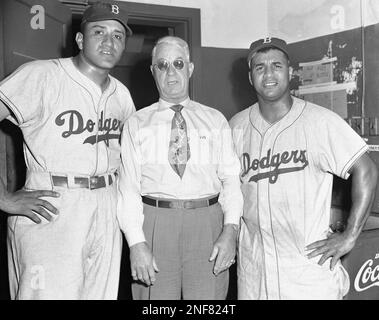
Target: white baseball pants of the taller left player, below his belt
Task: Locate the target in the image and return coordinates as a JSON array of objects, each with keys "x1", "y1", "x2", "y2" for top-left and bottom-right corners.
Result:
[{"x1": 8, "y1": 173, "x2": 122, "y2": 300}]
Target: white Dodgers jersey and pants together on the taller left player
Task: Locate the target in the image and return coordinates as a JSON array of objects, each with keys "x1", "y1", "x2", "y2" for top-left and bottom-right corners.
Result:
[{"x1": 0, "y1": 58, "x2": 135, "y2": 300}]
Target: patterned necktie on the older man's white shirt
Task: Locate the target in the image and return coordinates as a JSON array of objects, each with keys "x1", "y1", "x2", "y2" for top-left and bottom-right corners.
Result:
[{"x1": 168, "y1": 104, "x2": 191, "y2": 178}]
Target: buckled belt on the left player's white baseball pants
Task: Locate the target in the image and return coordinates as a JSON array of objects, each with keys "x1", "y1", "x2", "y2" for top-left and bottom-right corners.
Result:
[{"x1": 51, "y1": 174, "x2": 115, "y2": 190}]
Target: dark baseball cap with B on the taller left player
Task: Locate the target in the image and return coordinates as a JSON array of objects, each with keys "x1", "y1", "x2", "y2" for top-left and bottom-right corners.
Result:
[{"x1": 81, "y1": 2, "x2": 133, "y2": 36}]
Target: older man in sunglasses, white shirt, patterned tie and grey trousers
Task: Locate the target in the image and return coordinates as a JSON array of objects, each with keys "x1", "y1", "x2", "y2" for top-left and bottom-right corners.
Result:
[{"x1": 118, "y1": 36, "x2": 243, "y2": 300}]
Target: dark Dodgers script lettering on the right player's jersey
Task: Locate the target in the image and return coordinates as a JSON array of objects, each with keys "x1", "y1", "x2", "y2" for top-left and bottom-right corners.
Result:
[{"x1": 241, "y1": 149, "x2": 308, "y2": 184}]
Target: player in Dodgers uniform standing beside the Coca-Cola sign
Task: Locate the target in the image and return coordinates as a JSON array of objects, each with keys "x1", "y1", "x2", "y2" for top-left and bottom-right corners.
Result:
[{"x1": 230, "y1": 38, "x2": 377, "y2": 299}]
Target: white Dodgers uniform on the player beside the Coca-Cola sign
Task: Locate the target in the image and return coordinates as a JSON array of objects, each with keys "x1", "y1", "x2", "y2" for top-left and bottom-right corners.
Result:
[{"x1": 230, "y1": 97, "x2": 368, "y2": 299}]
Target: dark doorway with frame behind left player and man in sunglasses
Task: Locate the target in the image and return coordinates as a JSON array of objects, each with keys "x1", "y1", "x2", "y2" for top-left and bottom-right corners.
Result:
[{"x1": 61, "y1": 1, "x2": 201, "y2": 300}]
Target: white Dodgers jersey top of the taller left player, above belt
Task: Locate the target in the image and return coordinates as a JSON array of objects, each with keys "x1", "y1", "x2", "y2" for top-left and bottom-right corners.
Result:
[{"x1": 0, "y1": 58, "x2": 135, "y2": 184}]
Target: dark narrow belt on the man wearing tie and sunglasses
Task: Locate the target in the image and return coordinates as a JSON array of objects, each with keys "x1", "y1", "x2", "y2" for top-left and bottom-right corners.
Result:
[{"x1": 142, "y1": 195, "x2": 219, "y2": 209}]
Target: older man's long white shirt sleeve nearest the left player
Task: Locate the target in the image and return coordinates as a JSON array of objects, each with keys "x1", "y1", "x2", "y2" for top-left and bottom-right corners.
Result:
[{"x1": 117, "y1": 118, "x2": 146, "y2": 247}]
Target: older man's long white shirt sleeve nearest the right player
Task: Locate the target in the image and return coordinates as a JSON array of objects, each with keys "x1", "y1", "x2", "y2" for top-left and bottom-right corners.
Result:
[{"x1": 217, "y1": 118, "x2": 243, "y2": 224}]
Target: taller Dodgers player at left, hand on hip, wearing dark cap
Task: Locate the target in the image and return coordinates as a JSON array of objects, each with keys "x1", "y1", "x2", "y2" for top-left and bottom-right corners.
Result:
[{"x1": 0, "y1": 3, "x2": 135, "y2": 299}]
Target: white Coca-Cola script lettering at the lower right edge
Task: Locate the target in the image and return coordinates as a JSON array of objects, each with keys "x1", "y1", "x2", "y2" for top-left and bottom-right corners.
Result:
[{"x1": 354, "y1": 253, "x2": 379, "y2": 292}]
